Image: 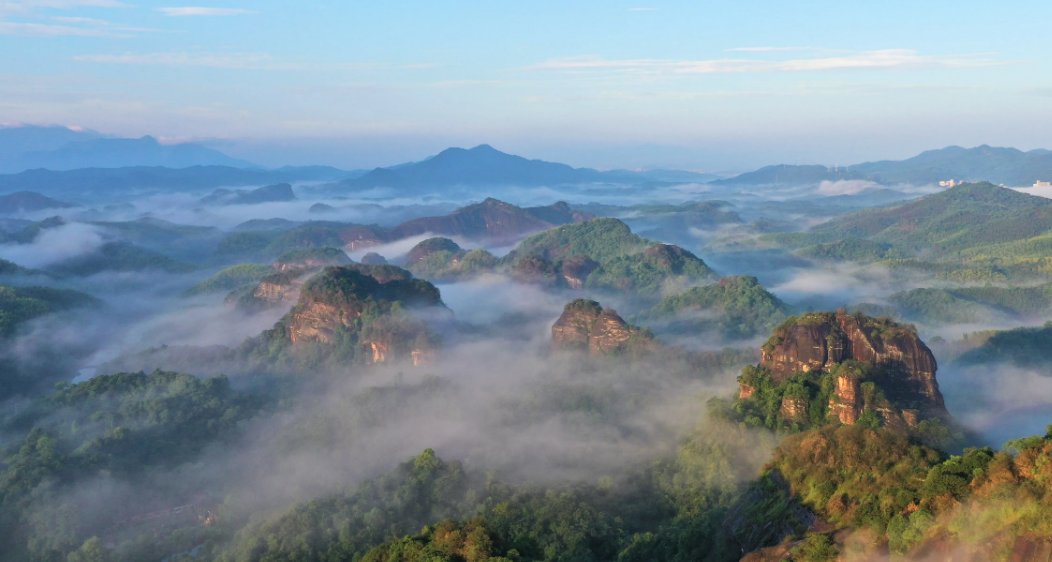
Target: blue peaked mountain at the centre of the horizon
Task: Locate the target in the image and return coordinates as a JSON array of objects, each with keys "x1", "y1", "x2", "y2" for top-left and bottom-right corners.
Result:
[{"x1": 340, "y1": 144, "x2": 711, "y2": 190}]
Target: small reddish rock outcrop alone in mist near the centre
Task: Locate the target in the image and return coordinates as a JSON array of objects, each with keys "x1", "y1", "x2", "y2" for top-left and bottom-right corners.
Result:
[{"x1": 551, "y1": 299, "x2": 655, "y2": 355}]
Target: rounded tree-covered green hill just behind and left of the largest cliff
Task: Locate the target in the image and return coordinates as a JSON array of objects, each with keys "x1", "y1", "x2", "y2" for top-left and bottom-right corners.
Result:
[{"x1": 632, "y1": 276, "x2": 791, "y2": 339}]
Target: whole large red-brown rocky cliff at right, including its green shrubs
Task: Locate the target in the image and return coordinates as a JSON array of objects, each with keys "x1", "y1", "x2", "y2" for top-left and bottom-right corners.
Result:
[{"x1": 739, "y1": 309, "x2": 951, "y2": 431}]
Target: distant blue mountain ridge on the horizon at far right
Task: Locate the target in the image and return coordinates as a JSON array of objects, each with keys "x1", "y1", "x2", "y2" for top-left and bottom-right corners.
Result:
[{"x1": 709, "y1": 144, "x2": 1052, "y2": 187}]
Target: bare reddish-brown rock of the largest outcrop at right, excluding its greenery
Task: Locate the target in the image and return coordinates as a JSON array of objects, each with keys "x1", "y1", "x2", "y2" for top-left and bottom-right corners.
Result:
[{"x1": 761, "y1": 309, "x2": 946, "y2": 417}]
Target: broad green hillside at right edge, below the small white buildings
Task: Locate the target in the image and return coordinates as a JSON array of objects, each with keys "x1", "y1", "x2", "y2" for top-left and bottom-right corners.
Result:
[{"x1": 750, "y1": 182, "x2": 1052, "y2": 282}]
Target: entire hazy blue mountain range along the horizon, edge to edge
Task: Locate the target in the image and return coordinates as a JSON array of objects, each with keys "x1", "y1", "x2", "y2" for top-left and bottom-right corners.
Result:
[{"x1": 0, "y1": 126, "x2": 1052, "y2": 194}]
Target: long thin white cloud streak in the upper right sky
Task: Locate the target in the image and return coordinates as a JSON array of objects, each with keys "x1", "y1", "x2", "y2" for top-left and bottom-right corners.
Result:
[{"x1": 526, "y1": 48, "x2": 1002, "y2": 75}]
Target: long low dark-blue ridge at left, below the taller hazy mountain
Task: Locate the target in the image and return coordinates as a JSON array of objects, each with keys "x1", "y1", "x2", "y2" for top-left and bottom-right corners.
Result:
[{"x1": 0, "y1": 166, "x2": 352, "y2": 200}]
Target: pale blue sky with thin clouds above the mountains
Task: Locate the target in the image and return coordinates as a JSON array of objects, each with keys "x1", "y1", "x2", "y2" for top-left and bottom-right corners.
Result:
[{"x1": 0, "y1": 0, "x2": 1052, "y2": 172}]
